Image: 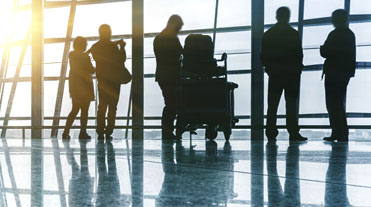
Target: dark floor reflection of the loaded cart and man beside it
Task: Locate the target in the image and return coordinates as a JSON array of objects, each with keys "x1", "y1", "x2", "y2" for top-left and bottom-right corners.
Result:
[{"x1": 156, "y1": 140, "x2": 237, "y2": 207}]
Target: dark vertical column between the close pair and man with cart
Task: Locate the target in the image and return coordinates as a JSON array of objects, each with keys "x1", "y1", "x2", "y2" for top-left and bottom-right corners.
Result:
[{"x1": 132, "y1": 0, "x2": 144, "y2": 139}]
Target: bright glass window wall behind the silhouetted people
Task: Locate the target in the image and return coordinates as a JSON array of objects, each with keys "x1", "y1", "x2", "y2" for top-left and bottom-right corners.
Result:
[{"x1": 0, "y1": 0, "x2": 371, "y2": 139}]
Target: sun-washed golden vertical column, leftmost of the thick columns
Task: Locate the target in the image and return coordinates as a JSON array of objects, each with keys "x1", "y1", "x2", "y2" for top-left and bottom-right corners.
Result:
[{"x1": 31, "y1": 0, "x2": 44, "y2": 138}]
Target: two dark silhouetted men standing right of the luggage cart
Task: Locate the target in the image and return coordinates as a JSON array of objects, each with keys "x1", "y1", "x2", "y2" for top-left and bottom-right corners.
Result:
[{"x1": 261, "y1": 7, "x2": 356, "y2": 141}]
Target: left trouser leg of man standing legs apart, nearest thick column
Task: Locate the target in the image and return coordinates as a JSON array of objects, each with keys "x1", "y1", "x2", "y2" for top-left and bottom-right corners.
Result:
[{"x1": 265, "y1": 77, "x2": 283, "y2": 138}]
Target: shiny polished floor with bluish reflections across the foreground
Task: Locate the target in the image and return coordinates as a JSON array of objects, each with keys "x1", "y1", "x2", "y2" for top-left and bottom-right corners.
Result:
[{"x1": 0, "y1": 138, "x2": 371, "y2": 207}]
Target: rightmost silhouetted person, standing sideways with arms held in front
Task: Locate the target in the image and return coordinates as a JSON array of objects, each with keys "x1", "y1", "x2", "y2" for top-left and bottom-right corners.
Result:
[{"x1": 321, "y1": 9, "x2": 356, "y2": 141}]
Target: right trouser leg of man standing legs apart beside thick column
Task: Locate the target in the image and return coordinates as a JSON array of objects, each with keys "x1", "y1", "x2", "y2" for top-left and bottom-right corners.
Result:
[{"x1": 285, "y1": 76, "x2": 300, "y2": 136}]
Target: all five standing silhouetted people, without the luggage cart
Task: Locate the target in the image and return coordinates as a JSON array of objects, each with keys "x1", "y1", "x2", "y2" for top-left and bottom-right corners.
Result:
[{"x1": 62, "y1": 7, "x2": 356, "y2": 141}]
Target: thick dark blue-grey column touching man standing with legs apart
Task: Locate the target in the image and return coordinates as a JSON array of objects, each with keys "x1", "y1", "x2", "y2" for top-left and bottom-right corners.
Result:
[{"x1": 251, "y1": 0, "x2": 264, "y2": 139}]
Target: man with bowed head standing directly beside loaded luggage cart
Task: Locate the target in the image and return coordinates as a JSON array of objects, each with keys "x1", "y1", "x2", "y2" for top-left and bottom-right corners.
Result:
[{"x1": 153, "y1": 15, "x2": 183, "y2": 139}]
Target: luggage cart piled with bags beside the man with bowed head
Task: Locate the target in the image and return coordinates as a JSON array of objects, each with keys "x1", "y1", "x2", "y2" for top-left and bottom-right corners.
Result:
[{"x1": 178, "y1": 34, "x2": 238, "y2": 140}]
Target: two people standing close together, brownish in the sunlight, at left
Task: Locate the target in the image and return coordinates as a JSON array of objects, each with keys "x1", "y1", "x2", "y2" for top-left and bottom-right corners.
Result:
[{"x1": 62, "y1": 24, "x2": 127, "y2": 140}]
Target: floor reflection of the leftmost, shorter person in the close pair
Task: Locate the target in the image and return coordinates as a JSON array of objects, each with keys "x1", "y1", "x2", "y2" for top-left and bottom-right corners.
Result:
[{"x1": 63, "y1": 140, "x2": 94, "y2": 207}]
